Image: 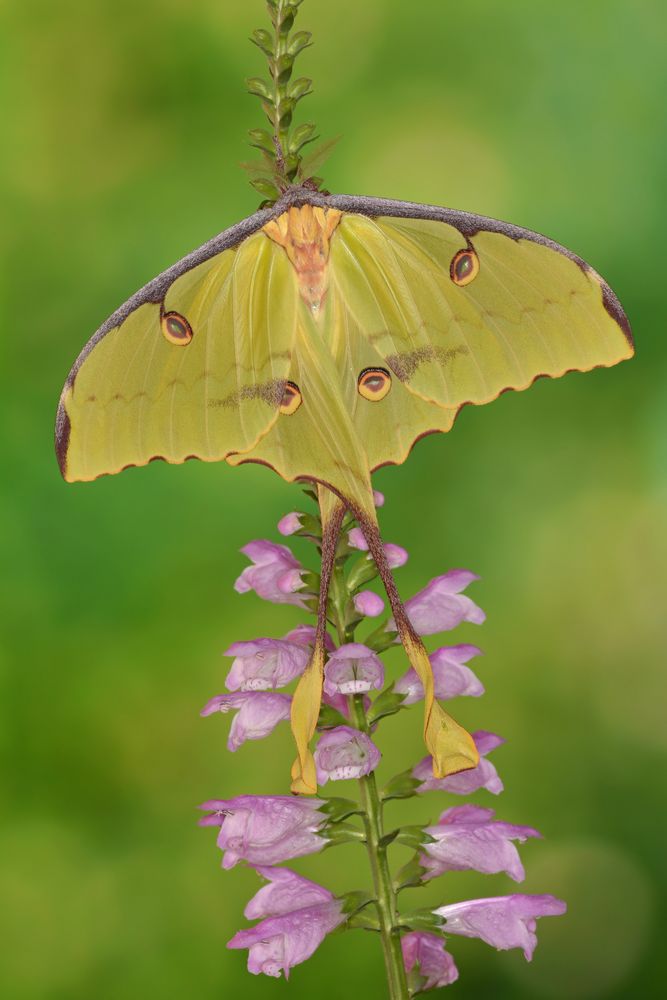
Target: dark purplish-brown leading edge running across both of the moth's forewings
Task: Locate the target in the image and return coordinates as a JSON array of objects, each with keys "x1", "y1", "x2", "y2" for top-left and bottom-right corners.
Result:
[{"x1": 55, "y1": 187, "x2": 634, "y2": 476}]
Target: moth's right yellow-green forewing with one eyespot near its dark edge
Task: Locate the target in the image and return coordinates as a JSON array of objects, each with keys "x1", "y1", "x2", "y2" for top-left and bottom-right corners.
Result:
[{"x1": 332, "y1": 203, "x2": 633, "y2": 422}]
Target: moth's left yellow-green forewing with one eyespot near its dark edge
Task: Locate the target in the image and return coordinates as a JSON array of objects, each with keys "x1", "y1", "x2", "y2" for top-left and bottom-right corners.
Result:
[{"x1": 56, "y1": 232, "x2": 299, "y2": 482}]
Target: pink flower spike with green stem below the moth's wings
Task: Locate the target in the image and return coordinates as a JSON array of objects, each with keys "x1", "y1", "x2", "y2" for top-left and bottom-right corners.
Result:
[{"x1": 201, "y1": 494, "x2": 565, "y2": 997}]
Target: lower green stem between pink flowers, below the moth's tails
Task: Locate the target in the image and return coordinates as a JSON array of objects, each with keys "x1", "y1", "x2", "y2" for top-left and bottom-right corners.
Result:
[{"x1": 350, "y1": 695, "x2": 409, "y2": 1000}]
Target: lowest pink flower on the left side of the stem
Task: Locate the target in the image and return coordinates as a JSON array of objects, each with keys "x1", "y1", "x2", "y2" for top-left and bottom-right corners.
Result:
[{"x1": 227, "y1": 899, "x2": 345, "y2": 979}]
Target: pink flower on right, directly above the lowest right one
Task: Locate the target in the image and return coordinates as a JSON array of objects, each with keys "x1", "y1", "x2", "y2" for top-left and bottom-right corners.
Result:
[{"x1": 420, "y1": 805, "x2": 540, "y2": 882}]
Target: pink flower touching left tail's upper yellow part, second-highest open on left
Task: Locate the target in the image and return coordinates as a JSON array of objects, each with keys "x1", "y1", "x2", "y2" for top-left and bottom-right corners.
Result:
[{"x1": 224, "y1": 639, "x2": 310, "y2": 691}]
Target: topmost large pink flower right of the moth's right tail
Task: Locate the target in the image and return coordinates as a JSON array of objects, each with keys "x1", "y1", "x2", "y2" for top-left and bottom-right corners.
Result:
[{"x1": 396, "y1": 569, "x2": 486, "y2": 635}]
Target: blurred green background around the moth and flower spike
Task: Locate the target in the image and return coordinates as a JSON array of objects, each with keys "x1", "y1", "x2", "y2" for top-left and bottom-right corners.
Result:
[{"x1": 0, "y1": 0, "x2": 667, "y2": 1000}]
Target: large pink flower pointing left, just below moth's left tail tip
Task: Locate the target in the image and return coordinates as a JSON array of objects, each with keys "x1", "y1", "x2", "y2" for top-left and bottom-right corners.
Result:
[{"x1": 200, "y1": 795, "x2": 326, "y2": 868}]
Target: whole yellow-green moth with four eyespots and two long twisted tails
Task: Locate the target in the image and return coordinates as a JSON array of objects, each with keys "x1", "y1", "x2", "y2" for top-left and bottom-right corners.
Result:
[{"x1": 56, "y1": 186, "x2": 633, "y2": 791}]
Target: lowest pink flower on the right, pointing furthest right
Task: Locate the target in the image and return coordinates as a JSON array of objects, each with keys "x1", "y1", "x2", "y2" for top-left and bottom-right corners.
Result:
[{"x1": 433, "y1": 895, "x2": 567, "y2": 962}]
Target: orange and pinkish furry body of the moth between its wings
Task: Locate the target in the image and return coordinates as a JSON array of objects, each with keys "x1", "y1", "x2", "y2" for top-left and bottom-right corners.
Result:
[{"x1": 264, "y1": 205, "x2": 342, "y2": 313}]
